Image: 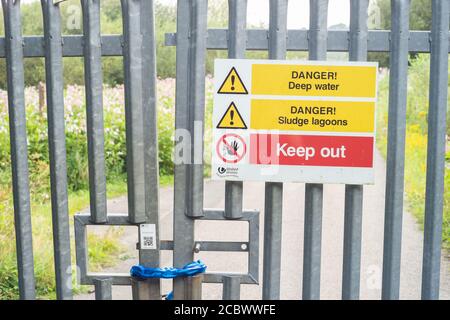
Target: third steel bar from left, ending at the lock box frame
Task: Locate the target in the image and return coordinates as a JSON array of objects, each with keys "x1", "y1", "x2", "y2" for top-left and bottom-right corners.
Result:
[{"x1": 81, "y1": 0, "x2": 107, "y2": 223}]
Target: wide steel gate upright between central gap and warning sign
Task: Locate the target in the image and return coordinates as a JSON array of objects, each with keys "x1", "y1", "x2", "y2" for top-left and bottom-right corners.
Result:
[{"x1": 173, "y1": 0, "x2": 208, "y2": 299}]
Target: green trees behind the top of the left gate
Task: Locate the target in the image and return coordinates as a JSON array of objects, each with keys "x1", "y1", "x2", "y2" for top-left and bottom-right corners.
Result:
[{"x1": 0, "y1": 1, "x2": 176, "y2": 89}]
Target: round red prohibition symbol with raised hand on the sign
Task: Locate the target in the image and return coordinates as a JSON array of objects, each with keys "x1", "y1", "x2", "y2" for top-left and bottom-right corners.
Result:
[{"x1": 216, "y1": 133, "x2": 247, "y2": 163}]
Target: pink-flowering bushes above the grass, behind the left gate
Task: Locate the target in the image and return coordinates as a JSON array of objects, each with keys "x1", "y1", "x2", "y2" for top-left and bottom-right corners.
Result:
[{"x1": 0, "y1": 79, "x2": 179, "y2": 191}]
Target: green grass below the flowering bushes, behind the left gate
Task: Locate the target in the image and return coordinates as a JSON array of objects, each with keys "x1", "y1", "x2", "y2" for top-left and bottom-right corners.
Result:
[{"x1": 0, "y1": 176, "x2": 173, "y2": 300}]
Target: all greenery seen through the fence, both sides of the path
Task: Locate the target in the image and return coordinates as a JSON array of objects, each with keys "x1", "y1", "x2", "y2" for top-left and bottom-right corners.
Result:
[{"x1": 0, "y1": 0, "x2": 450, "y2": 300}]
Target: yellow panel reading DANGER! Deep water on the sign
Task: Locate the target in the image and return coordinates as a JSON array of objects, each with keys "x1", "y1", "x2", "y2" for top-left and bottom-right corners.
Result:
[{"x1": 252, "y1": 64, "x2": 377, "y2": 98}]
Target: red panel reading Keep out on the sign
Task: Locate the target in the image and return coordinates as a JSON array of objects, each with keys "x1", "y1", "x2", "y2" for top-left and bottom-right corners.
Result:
[{"x1": 250, "y1": 134, "x2": 374, "y2": 168}]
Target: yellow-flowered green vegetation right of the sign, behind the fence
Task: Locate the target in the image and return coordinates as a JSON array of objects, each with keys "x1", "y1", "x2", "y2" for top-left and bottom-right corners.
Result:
[{"x1": 377, "y1": 55, "x2": 450, "y2": 249}]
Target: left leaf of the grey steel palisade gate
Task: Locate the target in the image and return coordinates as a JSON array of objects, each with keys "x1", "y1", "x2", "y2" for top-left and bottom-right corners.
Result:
[{"x1": 0, "y1": 0, "x2": 160, "y2": 299}]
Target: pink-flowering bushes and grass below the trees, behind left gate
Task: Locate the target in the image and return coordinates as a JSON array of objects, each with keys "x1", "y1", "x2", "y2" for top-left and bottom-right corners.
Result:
[{"x1": 0, "y1": 79, "x2": 179, "y2": 299}]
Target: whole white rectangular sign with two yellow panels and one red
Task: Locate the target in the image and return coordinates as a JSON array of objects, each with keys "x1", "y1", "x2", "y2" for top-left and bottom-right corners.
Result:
[{"x1": 212, "y1": 59, "x2": 378, "y2": 184}]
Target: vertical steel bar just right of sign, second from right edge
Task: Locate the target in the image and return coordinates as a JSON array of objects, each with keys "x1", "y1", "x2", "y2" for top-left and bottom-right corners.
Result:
[{"x1": 381, "y1": 0, "x2": 410, "y2": 299}]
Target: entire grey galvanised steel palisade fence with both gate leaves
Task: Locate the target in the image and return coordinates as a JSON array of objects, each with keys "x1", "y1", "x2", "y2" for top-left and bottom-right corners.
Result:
[{"x1": 0, "y1": 0, "x2": 449, "y2": 299}]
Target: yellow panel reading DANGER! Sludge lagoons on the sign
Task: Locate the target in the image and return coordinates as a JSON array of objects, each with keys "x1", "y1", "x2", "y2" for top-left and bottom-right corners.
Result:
[{"x1": 250, "y1": 100, "x2": 375, "y2": 133}]
